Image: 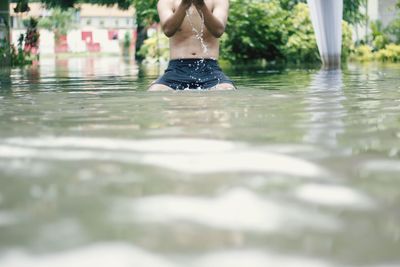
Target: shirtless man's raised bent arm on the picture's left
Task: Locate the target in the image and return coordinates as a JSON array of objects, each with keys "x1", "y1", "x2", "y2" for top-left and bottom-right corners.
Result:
[{"x1": 157, "y1": 0, "x2": 192, "y2": 37}]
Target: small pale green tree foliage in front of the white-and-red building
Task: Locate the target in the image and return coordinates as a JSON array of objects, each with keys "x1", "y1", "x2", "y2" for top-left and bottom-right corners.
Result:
[{"x1": 38, "y1": 7, "x2": 76, "y2": 39}]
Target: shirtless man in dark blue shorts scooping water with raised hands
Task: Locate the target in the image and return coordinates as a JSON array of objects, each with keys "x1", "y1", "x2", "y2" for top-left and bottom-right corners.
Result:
[{"x1": 149, "y1": 0, "x2": 235, "y2": 91}]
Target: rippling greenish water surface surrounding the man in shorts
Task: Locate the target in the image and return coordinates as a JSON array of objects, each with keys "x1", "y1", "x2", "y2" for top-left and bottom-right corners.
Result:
[{"x1": 0, "y1": 58, "x2": 400, "y2": 267}]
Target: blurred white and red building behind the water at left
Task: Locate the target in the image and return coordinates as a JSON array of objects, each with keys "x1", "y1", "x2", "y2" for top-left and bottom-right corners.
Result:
[{"x1": 10, "y1": 3, "x2": 136, "y2": 55}]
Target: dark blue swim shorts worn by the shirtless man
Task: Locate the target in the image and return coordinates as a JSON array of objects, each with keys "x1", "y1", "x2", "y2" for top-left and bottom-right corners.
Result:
[{"x1": 153, "y1": 59, "x2": 234, "y2": 90}]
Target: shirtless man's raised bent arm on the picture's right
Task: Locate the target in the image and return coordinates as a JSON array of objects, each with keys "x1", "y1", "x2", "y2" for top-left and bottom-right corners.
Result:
[{"x1": 193, "y1": 0, "x2": 229, "y2": 38}]
